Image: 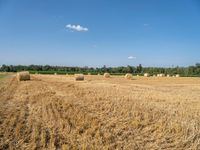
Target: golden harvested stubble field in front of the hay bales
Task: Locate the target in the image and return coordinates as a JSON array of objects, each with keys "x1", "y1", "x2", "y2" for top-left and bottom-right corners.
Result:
[{"x1": 0, "y1": 75, "x2": 200, "y2": 150}]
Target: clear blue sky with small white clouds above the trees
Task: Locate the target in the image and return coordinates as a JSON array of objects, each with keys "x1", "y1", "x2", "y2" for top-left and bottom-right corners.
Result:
[{"x1": 0, "y1": 0, "x2": 200, "y2": 67}]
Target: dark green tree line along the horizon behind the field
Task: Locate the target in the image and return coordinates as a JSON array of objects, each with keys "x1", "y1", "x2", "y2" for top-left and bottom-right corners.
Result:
[{"x1": 0, "y1": 63, "x2": 200, "y2": 76}]
